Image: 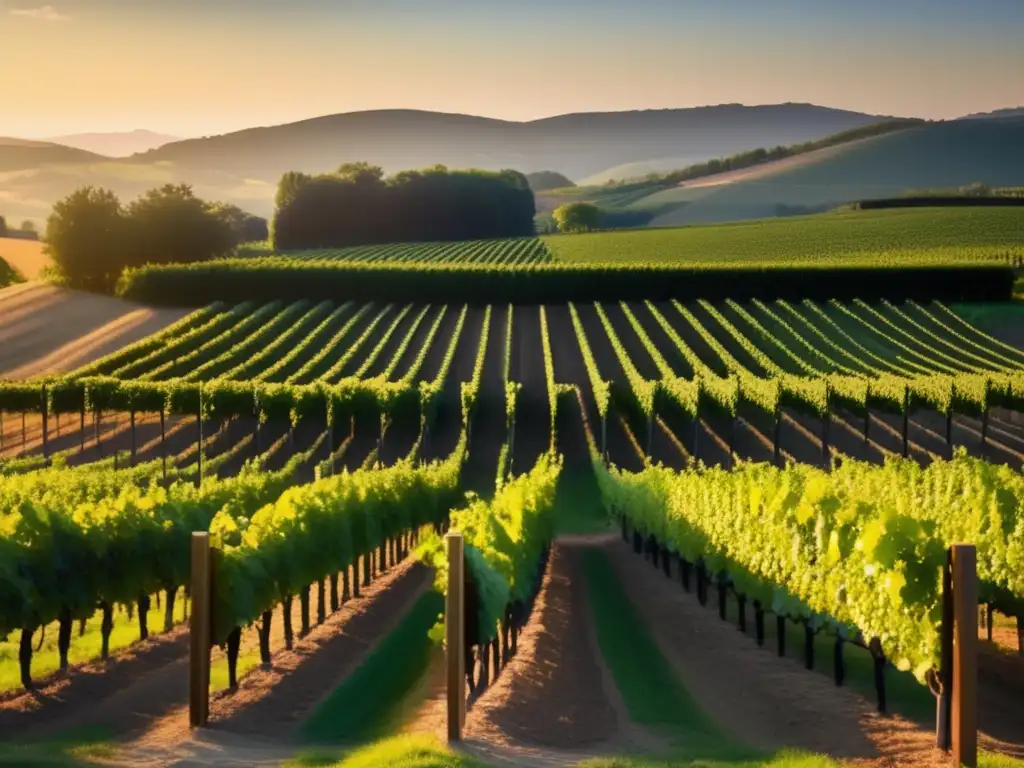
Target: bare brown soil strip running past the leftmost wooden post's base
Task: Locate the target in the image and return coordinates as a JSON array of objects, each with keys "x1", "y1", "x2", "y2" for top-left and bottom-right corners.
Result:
[{"x1": 0, "y1": 560, "x2": 430, "y2": 768}]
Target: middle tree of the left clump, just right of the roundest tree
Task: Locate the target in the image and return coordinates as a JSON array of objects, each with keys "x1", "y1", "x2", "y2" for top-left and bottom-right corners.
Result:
[{"x1": 125, "y1": 184, "x2": 234, "y2": 266}]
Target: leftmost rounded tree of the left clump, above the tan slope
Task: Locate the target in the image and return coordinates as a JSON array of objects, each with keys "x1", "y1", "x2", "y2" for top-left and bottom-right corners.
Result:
[{"x1": 46, "y1": 186, "x2": 127, "y2": 293}]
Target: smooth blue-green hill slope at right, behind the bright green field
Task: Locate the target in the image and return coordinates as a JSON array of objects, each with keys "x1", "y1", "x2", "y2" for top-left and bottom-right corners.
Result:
[{"x1": 643, "y1": 119, "x2": 1024, "y2": 226}]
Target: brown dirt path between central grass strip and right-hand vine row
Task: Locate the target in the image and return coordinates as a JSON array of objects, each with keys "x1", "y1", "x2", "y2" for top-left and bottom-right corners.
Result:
[{"x1": 606, "y1": 542, "x2": 1014, "y2": 768}]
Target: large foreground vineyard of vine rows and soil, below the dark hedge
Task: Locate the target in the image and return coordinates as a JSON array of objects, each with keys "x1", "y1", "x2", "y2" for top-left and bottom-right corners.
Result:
[{"x1": 0, "y1": 286, "x2": 1024, "y2": 766}]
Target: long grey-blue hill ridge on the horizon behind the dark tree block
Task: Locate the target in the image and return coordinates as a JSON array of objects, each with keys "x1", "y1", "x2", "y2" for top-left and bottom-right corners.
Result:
[{"x1": 140, "y1": 103, "x2": 880, "y2": 180}]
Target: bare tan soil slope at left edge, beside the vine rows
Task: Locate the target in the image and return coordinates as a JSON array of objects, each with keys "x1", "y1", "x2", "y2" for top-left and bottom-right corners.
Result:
[{"x1": 0, "y1": 283, "x2": 190, "y2": 379}]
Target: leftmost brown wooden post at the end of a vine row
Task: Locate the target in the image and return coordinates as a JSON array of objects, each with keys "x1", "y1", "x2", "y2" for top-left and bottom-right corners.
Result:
[{"x1": 188, "y1": 532, "x2": 213, "y2": 728}]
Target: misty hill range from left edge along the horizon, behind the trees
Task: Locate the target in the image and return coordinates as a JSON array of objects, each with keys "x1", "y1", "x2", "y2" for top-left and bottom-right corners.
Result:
[{"x1": 0, "y1": 104, "x2": 878, "y2": 225}]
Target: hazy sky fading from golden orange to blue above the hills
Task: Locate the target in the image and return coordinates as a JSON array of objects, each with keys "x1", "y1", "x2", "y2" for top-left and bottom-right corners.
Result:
[{"x1": 0, "y1": 0, "x2": 1024, "y2": 137}]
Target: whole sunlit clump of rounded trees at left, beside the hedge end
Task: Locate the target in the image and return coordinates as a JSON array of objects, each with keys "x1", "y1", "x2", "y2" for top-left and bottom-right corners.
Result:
[{"x1": 45, "y1": 184, "x2": 267, "y2": 293}]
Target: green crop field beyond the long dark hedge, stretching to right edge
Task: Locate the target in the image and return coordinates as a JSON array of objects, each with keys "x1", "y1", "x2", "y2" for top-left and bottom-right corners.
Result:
[{"x1": 266, "y1": 208, "x2": 1024, "y2": 267}]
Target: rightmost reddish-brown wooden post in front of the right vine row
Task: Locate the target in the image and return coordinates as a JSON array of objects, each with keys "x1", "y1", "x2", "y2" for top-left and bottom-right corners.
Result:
[{"x1": 951, "y1": 544, "x2": 978, "y2": 768}]
